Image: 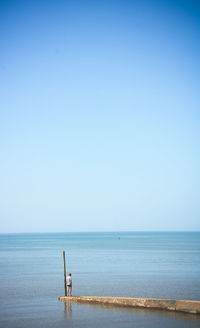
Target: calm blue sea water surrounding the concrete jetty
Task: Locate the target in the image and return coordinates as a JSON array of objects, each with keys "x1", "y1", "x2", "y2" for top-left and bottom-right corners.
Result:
[{"x1": 0, "y1": 232, "x2": 200, "y2": 328}]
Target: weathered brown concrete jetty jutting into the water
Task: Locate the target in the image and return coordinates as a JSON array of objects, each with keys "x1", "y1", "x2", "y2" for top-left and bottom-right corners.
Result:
[{"x1": 59, "y1": 296, "x2": 200, "y2": 314}]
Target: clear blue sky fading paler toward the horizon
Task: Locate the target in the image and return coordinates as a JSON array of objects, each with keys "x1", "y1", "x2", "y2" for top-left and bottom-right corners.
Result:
[{"x1": 0, "y1": 0, "x2": 200, "y2": 233}]
